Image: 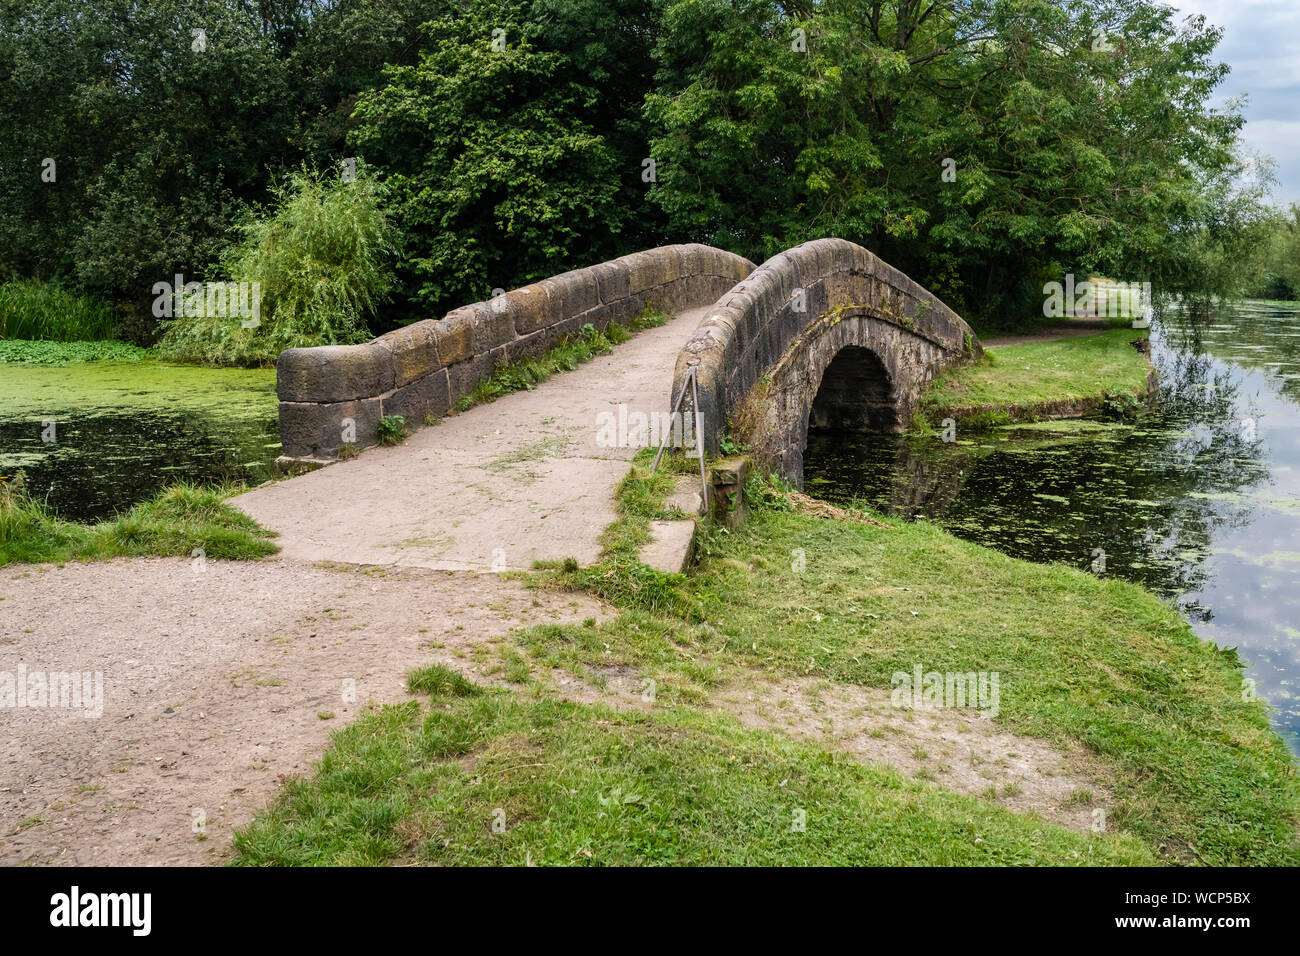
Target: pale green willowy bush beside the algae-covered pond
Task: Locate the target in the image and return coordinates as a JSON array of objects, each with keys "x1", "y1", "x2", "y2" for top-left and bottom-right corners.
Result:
[{"x1": 159, "y1": 168, "x2": 397, "y2": 365}]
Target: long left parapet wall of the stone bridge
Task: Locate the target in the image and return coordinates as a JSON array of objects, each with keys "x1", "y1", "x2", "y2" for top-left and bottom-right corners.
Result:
[{"x1": 276, "y1": 243, "x2": 754, "y2": 459}]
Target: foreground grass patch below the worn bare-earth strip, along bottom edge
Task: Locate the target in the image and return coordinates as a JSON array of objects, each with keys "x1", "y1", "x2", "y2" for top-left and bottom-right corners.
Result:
[{"x1": 235, "y1": 691, "x2": 1153, "y2": 866}]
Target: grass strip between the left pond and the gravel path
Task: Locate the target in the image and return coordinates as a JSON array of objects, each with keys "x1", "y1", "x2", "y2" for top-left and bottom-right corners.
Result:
[{"x1": 0, "y1": 475, "x2": 278, "y2": 567}]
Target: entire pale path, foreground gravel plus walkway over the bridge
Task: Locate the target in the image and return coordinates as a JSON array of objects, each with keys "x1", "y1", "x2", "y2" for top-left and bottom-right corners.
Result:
[{"x1": 0, "y1": 310, "x2": 703, "y2": 865}]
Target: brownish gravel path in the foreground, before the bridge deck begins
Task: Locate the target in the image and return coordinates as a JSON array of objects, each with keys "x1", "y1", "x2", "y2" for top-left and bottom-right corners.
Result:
[{"x1": 0, "y1": 558, "x2": 606, "y2": 866}]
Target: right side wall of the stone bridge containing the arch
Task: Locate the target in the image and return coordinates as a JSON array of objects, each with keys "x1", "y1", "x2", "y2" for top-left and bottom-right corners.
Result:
[{"x1": 672, "y1": 239, "x2": 982, "y2": 485}]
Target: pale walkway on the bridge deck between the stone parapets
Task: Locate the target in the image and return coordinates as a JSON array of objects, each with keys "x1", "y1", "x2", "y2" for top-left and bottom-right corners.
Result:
[{"x1": 233, "y1": 308, "x2": 707, "y2": 571}]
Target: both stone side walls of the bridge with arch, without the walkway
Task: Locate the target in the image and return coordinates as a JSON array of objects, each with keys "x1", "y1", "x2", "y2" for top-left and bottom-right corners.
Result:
[{"x1": 277, "y1": 239, "x2": 980, "y2": 484}]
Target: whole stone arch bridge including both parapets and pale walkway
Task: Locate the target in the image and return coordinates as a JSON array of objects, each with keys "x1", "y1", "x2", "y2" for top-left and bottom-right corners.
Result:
[{"x1": 234, "y1": 239, "x2": 980, "y2": 571}]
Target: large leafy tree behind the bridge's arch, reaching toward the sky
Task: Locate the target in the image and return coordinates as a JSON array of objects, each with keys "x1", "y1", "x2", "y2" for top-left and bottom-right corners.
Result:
[{"x1": 646, "y1": 0, "x2": 1258, "y2": 323}]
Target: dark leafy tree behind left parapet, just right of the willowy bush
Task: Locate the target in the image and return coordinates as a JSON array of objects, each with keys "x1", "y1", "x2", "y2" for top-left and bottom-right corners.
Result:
[{"x1": 350, "y1": 0, "x2": 653, "y2": 312}]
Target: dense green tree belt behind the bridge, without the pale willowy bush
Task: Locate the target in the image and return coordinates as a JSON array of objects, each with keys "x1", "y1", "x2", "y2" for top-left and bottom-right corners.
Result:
[{"x1": 0, "y1": 0, "x2": 1291, "y2": 356}]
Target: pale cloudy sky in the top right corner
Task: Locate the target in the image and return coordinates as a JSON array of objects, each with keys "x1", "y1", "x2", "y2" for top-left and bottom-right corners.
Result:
[{"x1": 1167, "y1": 0, "x2": 1300, "y2": 204}]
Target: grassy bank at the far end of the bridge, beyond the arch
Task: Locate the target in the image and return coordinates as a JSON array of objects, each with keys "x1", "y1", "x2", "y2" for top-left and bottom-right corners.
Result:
[{"x1": 917, "y1": 329, "x2": 1152, "y2": 425}]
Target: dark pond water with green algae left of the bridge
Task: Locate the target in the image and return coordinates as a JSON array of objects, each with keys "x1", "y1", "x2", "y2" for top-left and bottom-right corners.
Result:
[{"x1": 0, "y1": 359, "x2": 280, "y2": 522}]
